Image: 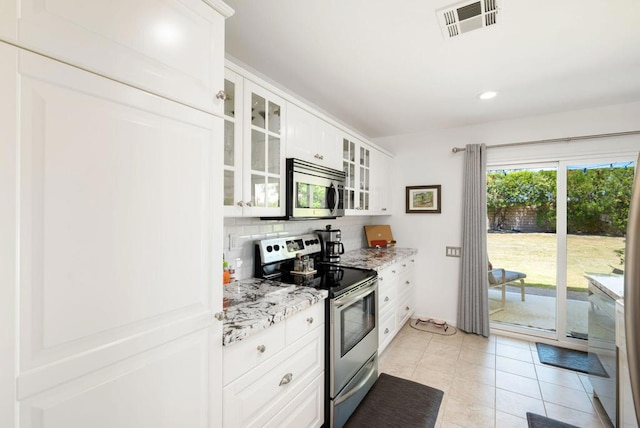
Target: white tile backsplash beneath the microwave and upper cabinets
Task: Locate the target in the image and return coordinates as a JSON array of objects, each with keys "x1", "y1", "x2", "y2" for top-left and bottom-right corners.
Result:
[{"x1": 223, "y1": 216, "x2": 385, "y2": 279}]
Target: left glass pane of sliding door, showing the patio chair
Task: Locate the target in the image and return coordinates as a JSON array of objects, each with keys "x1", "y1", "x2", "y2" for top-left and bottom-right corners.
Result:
[{"x1": 487, "y1": 164, "x2": 557, "y2": 336}]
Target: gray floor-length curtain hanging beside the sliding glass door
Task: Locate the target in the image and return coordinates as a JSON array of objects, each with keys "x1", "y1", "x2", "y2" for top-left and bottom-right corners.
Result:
[{"x1": 457, "y1": 144, "x2": 489, "y2": 337}]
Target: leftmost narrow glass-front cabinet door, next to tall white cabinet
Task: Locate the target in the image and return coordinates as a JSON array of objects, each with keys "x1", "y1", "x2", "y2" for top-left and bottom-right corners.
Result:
[{"x1": 223, "y1": 70, "x2": 244, "y2": 217}]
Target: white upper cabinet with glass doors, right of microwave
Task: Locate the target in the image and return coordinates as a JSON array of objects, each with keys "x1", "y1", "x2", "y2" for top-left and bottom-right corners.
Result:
[{"x1": 342, "y1": 136, "x2": 371, "y2": 215}]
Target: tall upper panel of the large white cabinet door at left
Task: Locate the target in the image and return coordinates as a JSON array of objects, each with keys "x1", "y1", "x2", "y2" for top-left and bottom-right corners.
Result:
[{"x1": 12, "y1": 49, "x2": 222, "y2": 412}]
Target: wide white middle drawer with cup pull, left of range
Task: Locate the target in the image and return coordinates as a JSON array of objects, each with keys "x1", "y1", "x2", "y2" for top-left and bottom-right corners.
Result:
[{"x1": 223, "y1": 328, "x2": 324, "y2": 427}]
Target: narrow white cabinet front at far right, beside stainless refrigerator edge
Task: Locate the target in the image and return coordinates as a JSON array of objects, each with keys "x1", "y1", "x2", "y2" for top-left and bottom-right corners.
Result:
[{"x1": 616, "y1": 300, "x2": 638, "y2": 428}]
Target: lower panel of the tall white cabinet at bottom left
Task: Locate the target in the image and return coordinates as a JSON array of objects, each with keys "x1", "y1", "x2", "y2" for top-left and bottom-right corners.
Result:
[{"x1": 20, "y1": 330, "x2": 215, "y2": 428}]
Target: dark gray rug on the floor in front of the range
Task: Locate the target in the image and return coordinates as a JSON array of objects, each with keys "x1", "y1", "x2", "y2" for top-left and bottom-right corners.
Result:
[{"x1": 345, "y1": 373, "x2": 444, "y2": 428}]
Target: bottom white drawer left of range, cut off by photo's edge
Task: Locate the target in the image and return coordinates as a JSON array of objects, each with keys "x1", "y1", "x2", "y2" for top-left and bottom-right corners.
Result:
[{"x1": 264, "y1": 374, "x2": 324, "y2": 428}]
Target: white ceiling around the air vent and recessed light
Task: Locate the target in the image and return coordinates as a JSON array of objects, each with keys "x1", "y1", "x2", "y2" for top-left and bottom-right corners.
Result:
[{"x1": 225, "y1": 0, "x2": 640, "y2": 138}]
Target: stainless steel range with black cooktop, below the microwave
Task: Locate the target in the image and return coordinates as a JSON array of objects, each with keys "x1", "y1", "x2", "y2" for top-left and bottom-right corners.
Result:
[{"x1": 254, "y1": 233, "x2": 378, "y2": 427}]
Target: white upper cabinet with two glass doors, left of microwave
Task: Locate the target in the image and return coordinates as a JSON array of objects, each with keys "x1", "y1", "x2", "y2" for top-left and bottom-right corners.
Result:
[{"x1": 224, "y1": 70, "x2": 285, "y2": 217}]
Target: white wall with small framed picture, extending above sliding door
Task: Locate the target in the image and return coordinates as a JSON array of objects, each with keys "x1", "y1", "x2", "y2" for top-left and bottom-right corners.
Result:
[{"x1": 375, "y1": 100, "x2": 640, "y2": 325}]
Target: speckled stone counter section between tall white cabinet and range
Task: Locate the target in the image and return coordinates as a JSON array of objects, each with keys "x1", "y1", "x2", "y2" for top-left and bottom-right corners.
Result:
[{"x1": 222, "y1": 278, "x2": 328, "y2": 346}]
